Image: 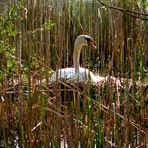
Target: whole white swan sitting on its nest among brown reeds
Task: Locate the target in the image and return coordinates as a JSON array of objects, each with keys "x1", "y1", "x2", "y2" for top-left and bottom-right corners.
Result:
[{"x1": 49, "y1": 35, "x2": 103, "y2": 82}]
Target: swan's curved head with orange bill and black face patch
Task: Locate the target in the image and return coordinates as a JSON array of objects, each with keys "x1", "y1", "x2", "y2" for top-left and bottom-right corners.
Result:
[{"x1": 75, "y1": 35, "x2": 97, "y2": 49}]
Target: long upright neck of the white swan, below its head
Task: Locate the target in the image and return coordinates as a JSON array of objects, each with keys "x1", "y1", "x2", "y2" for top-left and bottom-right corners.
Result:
[{"x1": 73, "y1": 42, "x2": 82, "y2": 73}]
